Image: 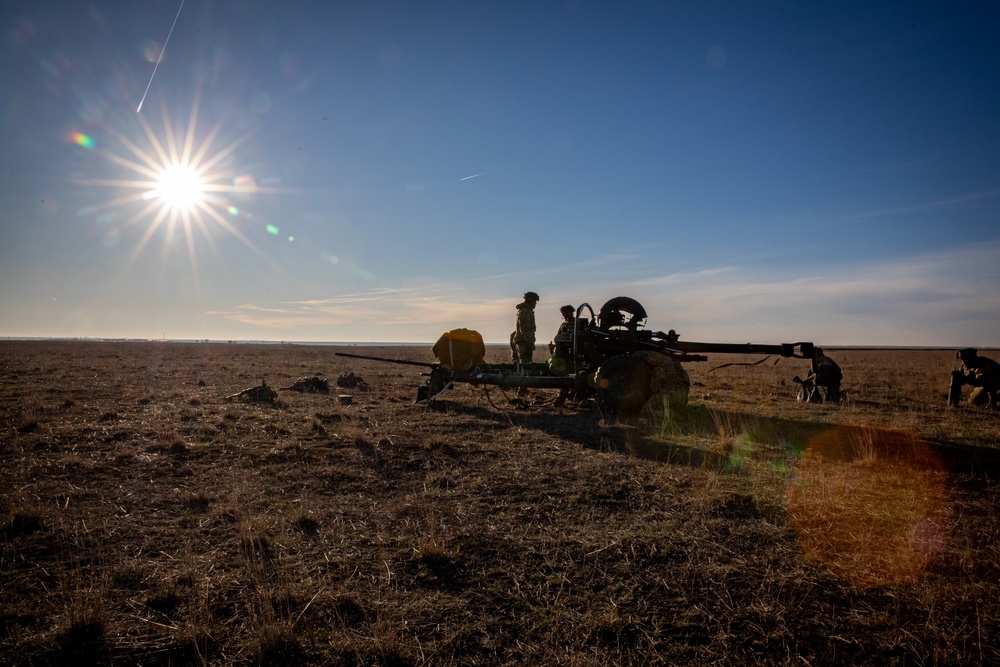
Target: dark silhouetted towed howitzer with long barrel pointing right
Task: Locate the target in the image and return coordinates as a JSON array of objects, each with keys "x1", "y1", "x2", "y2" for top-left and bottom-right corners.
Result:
[{"x1": 337, "y1": 296, "x2": 813, "y2": 413}]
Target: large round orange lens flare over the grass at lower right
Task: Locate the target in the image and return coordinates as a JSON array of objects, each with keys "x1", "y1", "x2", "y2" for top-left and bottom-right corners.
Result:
[{"x1": 788, "y1": 426, "x2": 949, "y2": 588}]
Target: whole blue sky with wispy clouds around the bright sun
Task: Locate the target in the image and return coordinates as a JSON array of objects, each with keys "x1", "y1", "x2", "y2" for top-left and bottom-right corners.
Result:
[{"x1": 0, "y1": 5, "x2": 1000, "y2": 346}]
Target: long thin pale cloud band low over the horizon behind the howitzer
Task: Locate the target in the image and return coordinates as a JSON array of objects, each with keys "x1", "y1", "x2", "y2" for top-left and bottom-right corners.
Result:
[{"x1": 207, "y1": 243, "x2": 1000, "y2": 346}]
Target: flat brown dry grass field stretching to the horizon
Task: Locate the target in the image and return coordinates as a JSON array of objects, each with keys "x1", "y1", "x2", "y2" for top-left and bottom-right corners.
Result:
[{"x1": 0, "y1": 342, "x2": 1000, "y2": 667}]
